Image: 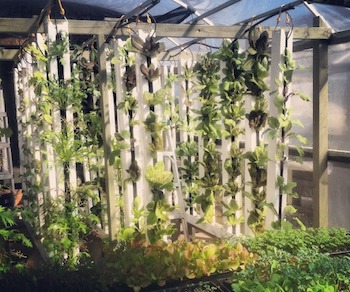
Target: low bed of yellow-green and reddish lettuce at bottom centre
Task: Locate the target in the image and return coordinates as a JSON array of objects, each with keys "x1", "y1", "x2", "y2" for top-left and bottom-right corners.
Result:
[{"x1": 104, "y1": 241, "x2": 254, "y2": 291}]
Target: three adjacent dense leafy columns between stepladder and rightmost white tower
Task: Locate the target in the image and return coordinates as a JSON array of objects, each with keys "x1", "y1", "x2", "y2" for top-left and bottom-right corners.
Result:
[{"x1": 192, "y1": 29, "x2": 270, "y2": 229}]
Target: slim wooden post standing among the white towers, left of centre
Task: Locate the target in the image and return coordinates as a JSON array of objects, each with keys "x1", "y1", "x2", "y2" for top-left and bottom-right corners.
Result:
[{"x1": 98, "y1": 34, "x2": 118, "y2": 240}]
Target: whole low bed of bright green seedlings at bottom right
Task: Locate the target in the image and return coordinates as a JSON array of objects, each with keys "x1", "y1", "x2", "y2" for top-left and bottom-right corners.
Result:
[{"x1": 232, "y1": 228, "x2": 350, "y2": 291}]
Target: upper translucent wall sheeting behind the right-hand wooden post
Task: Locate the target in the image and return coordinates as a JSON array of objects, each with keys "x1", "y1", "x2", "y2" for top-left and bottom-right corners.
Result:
[{"x1": 292, "y1": 44, "x2": 350, "y2": 151}]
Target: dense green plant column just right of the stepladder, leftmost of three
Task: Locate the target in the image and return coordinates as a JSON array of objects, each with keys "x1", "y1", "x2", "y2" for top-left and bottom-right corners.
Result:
[{"x1": 193, "y1": 53, "x2": 222, "y2": 223}]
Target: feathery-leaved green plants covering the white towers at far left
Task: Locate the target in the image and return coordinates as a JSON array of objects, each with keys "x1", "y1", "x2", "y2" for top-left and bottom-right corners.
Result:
[{"x1": 19, "y1": 34, "x2": 104, "y2": 266}]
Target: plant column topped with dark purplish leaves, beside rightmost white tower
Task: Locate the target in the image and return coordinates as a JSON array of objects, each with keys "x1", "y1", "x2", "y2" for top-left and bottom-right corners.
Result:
[{"x1": 244, "y1": 27, "x2": 270, "y2": 233}]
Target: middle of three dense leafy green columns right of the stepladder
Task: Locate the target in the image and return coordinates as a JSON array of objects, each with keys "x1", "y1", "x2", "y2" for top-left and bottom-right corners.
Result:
[{"x1": 219, "y1": 40, "x2": 247, "y2": 225}]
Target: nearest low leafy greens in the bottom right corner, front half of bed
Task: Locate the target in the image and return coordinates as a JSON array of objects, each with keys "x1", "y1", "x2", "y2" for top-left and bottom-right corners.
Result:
[{"x1": 232, "y1": 249, "x2": 350, "y2": 291}]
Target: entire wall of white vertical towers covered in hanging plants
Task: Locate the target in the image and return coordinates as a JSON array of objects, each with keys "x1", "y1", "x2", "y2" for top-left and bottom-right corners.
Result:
[{"x1": 15, "y1": 21, "x2": 304, "y2": 250}]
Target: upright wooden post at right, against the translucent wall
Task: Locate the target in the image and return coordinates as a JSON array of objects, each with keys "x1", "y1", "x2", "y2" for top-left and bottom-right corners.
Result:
[{"x1": 313, "y1": 17, "x2": 328, "y2": 227}]
